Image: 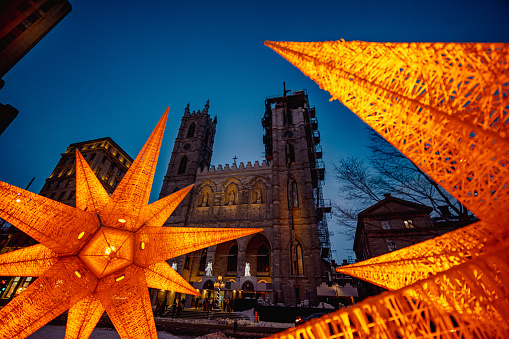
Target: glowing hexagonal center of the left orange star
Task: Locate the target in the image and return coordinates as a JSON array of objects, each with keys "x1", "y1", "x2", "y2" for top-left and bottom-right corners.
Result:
[{"x1": 78, "y1": 227, "x2": 134, "y2": 278}]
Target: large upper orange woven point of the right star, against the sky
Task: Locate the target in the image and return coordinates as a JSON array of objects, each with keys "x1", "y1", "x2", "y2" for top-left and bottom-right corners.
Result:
[{"x1": 266, "y1": 41, "x2": 509, "y2": 224}]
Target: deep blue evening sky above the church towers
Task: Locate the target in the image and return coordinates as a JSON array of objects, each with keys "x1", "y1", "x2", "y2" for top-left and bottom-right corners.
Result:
[{"x1": 0, "y1": 0, "x2": 509, "y2": 260}]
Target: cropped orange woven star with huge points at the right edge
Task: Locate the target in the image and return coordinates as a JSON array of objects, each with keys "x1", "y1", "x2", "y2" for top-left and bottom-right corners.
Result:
[{"x1": 265, "y1": 41, "x2": 509, "y2": 339}]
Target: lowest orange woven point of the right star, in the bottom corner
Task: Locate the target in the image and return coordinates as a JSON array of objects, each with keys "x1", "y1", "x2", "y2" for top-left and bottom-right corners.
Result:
[{"x1": 271, "y1": 247, "x2": 509, "y2": 339}]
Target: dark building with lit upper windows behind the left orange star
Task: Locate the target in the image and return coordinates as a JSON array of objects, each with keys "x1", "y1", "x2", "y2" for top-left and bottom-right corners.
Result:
[{"x1": 0, "y1": 137, "x2": 133, "y2": 305}]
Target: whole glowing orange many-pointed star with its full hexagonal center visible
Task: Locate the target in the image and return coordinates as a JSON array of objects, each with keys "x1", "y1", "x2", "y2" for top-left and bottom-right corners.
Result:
[{"x1": 0, "y1": 108, "x2": 261, "y2": 339}]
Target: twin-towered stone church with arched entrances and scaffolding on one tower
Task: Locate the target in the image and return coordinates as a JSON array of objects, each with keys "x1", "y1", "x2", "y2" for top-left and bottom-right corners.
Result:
[{"x1": 159, "y1": 91, "x2": 330, "y2": 306}]
